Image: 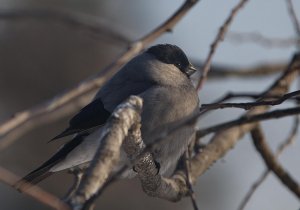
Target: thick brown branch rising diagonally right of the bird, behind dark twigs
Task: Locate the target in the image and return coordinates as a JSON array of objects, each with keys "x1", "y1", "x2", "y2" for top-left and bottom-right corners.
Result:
[{"x1": 190, "y1": 54, "x2": 300, "y2": 182}]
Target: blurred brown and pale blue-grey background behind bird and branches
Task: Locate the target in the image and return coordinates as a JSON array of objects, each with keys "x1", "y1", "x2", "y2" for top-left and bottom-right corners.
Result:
[{"x1": 0, "y1": 0, "x2": 300, "y2": 210}]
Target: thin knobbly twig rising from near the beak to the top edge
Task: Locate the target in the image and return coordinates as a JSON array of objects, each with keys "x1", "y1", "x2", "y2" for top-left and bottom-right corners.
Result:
[{"x1": 197, "y1": 0, "x2": 248, "y2": 90}]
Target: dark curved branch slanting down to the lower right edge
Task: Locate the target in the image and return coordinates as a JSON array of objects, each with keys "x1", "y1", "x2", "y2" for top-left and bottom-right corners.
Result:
[{"x1": 251, "y1": 126, "x2": 300, "y2": 198}]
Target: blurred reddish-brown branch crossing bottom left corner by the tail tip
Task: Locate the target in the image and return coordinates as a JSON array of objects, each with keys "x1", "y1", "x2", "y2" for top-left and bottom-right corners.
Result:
[{"x1": 0, "y1": 166, "x2": 70, "y2": 210}]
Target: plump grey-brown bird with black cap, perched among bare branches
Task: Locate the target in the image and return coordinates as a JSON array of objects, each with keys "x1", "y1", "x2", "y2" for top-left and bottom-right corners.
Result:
[{"x1": 15, "y1": 44, "x2": 200, "y2": 191}]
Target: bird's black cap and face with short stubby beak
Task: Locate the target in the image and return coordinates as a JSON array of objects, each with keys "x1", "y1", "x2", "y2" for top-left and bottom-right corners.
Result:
[{"x1": 146, "y1": 44, "x2": 197, "y2": 77}]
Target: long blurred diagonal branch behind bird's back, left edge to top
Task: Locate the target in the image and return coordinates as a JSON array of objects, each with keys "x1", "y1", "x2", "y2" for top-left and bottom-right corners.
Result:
[{"x1": 0, "y1": 0, "x2": 198, "y2": 150}]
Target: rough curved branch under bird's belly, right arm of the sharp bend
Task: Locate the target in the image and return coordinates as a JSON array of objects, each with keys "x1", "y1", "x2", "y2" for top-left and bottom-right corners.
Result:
[{"x1": 123, "y1": 123, "x2": 188, "y2": 201}]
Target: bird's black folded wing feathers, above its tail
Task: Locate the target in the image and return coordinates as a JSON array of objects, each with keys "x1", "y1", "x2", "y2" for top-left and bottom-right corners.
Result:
[{"x1": 50, "y1": 98, "x2": 111, "y2": 141}]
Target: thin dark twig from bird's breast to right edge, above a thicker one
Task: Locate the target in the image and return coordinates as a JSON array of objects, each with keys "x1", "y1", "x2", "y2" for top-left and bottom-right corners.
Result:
[{"x1": 200, "y1": 90, "x2": 300, "y2": 111}]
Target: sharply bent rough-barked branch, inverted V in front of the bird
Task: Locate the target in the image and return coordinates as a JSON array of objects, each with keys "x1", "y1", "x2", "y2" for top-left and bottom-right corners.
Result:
[{"x1": 67, "y1": 96, "x2": 188, "y2": 207}]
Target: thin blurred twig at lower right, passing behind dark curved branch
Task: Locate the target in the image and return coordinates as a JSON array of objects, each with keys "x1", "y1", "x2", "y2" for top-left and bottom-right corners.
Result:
[{"x1": 238, "y1": 116, "x2": 300, "y2": 210}]
